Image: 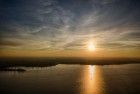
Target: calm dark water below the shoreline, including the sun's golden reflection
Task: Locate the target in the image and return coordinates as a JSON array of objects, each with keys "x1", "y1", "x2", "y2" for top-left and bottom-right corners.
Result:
[{"x1": 0, "y1": 64, "x2": 140, "y2": 94}]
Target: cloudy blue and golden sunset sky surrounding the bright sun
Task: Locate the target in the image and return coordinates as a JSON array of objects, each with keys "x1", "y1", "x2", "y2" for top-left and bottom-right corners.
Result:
[{"x1": 0, "y1": 0, "x2": 140, "y2": 57}]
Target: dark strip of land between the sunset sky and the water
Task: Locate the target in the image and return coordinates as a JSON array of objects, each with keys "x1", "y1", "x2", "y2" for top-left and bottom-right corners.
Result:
[{"x1": 0, "y1": 57, "x2": 140, "y2": 72}]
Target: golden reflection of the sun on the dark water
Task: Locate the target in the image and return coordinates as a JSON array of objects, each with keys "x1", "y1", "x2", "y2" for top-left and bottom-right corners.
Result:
[{"x1": 81, "y1": 65, "x2": 104, "y2": 94}]
